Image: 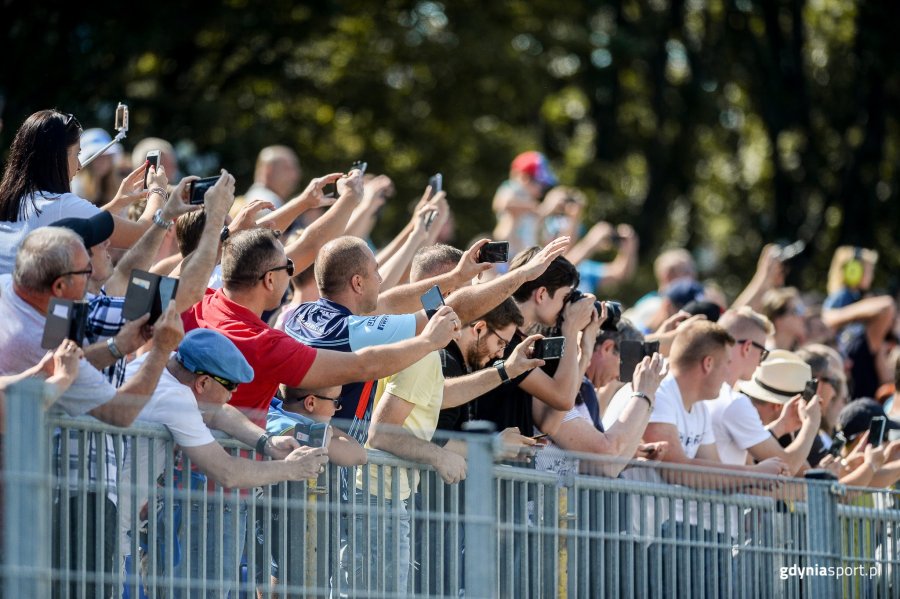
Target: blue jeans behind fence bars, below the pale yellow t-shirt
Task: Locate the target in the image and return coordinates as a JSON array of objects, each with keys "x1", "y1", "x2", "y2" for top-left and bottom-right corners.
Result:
[{"x1": 341, "y1": 491, "x2": 410, "y2": 595}]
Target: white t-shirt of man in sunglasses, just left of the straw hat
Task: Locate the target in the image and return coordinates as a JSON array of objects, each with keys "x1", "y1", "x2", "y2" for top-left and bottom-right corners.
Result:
[{"x1": 701, "y1": 383, "x2": 772, "y2": 465}]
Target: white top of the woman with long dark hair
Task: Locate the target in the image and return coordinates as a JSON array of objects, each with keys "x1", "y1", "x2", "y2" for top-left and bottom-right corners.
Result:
[{"x1": 0, "y1": 192, "x2": 100, "y2": 274}]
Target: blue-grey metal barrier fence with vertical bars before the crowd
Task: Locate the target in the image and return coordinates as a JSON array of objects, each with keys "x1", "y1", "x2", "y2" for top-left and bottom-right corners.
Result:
[{"x1": 3, "y1": 384, "x2": 900, "y2": 599}]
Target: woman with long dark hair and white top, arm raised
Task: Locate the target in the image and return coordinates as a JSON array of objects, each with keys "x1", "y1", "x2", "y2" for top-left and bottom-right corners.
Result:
[{"x1": 0, "y1": 110, "x2": 168, "y2": 274}]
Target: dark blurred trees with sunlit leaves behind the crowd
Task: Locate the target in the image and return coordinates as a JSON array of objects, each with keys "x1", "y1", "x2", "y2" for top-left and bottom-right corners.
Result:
[{"x1": 0, "y1": 0, "x2": 900, "y2": 296}]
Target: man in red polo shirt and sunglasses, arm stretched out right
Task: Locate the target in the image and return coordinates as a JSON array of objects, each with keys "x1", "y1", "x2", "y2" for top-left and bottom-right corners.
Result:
[{"x1": 182, "y1": 171, "x2": 460, "y2": 434}]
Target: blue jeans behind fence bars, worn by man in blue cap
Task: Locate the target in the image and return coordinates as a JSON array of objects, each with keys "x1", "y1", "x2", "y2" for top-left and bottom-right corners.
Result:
[{"x1": 174, "y1": 497, "x2": 247, "y2": 597}]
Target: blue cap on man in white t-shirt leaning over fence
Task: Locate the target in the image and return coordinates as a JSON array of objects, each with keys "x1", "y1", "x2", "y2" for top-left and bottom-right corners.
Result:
[{"x1": 175, "y1": 329, "x2": 253, "y2": 383}]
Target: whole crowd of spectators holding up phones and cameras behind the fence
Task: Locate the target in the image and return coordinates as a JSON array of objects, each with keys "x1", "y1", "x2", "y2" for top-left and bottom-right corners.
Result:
[{"x1": 0, "y1": 110, "x2": 900, "y2": 594}]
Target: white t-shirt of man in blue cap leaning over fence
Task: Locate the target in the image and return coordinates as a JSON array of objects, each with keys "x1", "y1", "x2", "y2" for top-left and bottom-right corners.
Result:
[{"x1": 119, "y1": 354, "x2": 215, "y2": 547}]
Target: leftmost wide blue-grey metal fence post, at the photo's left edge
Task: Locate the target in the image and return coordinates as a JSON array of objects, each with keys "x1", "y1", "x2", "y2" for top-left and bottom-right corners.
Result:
[{"x1": 3, "y1": 379, "x2": 52, "y2": 597}]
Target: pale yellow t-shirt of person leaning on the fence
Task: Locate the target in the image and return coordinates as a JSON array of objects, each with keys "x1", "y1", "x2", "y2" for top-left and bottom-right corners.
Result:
[{"x1": 356, "y1": 352, "x2": 444, "y2": 499}]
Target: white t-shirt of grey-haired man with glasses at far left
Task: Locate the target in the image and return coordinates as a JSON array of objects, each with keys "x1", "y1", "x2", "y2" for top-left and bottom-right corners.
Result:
[{"x1": 0, "y1": 274, "x2": 116, "y2": 416}]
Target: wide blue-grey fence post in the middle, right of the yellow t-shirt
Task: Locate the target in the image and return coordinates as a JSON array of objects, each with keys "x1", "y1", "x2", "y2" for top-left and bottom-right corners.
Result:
[{"x1": 464, "y1": 420, "x2": 497, "y2": 598}]
